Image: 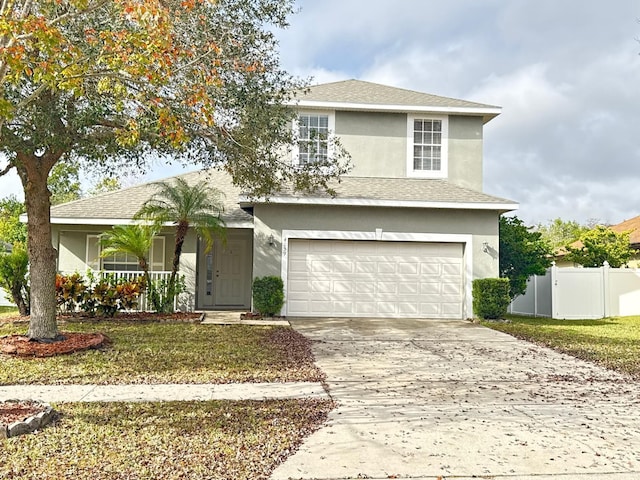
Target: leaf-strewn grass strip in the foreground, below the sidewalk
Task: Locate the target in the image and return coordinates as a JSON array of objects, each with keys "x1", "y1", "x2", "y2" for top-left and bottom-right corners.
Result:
[{"x1": 0, "y1": 399, "x2": 333, "y2": 480}]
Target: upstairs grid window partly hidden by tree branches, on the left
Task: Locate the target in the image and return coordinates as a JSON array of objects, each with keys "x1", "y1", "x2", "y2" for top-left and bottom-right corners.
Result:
[{"x1": 295, "y1": 113, "x2": 334, "y2": 165}]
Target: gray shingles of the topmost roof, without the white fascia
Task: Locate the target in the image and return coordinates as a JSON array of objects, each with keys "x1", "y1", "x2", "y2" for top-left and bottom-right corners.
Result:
[{"x1": 299, "y1": 80, "x2": 500, "y2": 109}]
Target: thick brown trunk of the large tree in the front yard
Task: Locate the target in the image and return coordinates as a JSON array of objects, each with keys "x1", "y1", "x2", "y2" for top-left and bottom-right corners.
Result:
[{"x1": 17, "y1": 154, "x2": 60, "y2": 340}]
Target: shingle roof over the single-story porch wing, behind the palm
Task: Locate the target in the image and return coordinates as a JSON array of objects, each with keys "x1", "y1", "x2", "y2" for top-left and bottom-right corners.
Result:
[{"x1": 51, "y1": 170, "x2": 253, "y2": 228}]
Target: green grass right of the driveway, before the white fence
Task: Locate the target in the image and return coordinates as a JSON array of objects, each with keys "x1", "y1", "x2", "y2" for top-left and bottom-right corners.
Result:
[{"x1": 483, "y1": 316, "x2": 640, "y2": 379}]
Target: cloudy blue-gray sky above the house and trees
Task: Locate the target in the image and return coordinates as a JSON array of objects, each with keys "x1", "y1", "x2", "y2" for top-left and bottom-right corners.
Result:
[{"x1": 0, "y1": 0, "x2": 640, "y2": 225}]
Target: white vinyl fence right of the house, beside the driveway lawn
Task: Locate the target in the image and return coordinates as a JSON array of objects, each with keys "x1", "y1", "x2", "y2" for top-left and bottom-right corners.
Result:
[{"x1": 509, "y1": 263, "x2": 640, "y2": 319}]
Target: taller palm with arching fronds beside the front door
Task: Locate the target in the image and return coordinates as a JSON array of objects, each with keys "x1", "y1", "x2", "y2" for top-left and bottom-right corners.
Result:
[{"x1": 135, "y1": 177, "x2": 225, "y2": 310}]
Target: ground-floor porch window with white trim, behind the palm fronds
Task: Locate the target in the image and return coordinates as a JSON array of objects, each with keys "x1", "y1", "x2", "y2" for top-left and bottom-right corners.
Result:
[{"x1": 86, "y1": 235, "x2": 165, "y2": 272}]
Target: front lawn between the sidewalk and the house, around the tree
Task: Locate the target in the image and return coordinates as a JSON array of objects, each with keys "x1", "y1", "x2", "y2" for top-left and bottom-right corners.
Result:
[{"x1": 0, "y1": 321, "x2": 323, "y2": 385}]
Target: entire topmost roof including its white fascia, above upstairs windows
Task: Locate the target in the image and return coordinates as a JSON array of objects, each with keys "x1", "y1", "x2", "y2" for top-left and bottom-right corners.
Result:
[{"x1": 293, "y1": 80, "x2": 501, "y2": 123}]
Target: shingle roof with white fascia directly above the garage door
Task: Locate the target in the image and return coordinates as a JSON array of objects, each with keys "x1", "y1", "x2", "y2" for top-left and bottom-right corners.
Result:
[{"x1": 240, "y1": 176, "x2": 518, "y2": 212}]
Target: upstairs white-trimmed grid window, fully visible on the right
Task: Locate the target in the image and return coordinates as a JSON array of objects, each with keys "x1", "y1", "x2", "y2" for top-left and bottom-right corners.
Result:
[{"x1": 407, "y1": 115, "x2": 448, "y2": 178}]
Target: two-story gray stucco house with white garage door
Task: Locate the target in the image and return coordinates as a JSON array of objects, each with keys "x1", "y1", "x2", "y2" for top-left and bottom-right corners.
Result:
[{"x1": 51, "y1": 80, "x2": 517, "y2": 319}]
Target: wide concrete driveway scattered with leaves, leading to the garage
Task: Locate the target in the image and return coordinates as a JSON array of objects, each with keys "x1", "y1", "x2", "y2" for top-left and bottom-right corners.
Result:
[{"x1": 272, "y1": 319, "x2": 640, "y2": 480}]
